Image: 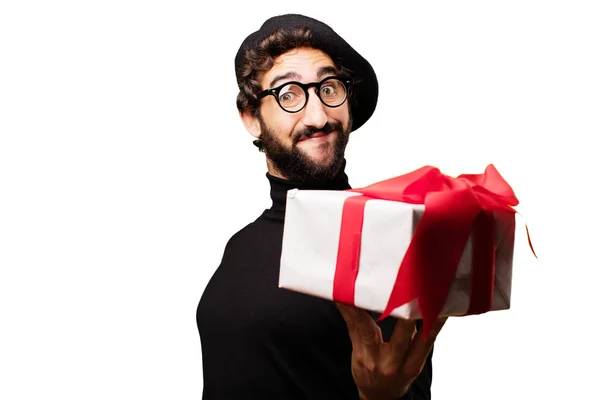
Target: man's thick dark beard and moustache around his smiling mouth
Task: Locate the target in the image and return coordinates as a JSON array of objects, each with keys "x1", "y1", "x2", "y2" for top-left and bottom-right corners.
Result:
[{"x1": 258, "y1": 116, "x2": 352, "y2": 182}]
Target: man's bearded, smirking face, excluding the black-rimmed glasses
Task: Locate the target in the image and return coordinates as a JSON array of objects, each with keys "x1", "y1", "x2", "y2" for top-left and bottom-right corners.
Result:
[{"x1": 244, "y1": 48, "x2": 351, "y2": 181}]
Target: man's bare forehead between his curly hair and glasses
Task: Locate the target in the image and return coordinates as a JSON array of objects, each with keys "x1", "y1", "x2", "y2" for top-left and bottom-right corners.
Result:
[{"x1": 261, "y1": 47, "x2": 336, "y2": 88}]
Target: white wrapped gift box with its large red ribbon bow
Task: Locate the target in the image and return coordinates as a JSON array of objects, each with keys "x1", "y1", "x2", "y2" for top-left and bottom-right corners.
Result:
[{"x1": 279, "y1": 165, "x2": 518, "y2": 336}]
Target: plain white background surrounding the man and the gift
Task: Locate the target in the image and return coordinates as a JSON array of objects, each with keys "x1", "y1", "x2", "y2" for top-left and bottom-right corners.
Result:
[{"x1": 0, "y1": 0, "x2": 600, "y2": 400}]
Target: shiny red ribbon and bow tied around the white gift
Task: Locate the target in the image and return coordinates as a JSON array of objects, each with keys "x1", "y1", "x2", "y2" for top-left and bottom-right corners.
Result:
[{"x1": 333, "y1": 164, "x2": 535, "y2": 337}]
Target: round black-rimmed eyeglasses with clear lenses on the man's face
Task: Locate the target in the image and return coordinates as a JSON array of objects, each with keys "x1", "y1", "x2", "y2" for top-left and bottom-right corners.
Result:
[{"x1": 258, "y1": 76, "x2": 352, "y2": 113}]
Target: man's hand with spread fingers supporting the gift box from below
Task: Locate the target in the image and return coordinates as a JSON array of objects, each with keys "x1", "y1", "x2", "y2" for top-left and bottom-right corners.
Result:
[{"x1": 336, "y1": 303, "x2": 447, "y2": 400}]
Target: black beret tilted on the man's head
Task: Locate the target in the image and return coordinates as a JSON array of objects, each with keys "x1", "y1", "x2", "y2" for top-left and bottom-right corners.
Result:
[{"x1": 235, "y1": 14, "x2": 379, "y2": 131}]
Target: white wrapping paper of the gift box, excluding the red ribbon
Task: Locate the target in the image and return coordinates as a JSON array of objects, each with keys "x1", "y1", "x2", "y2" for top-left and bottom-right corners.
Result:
[{"x1": 279, "y1": 189, "x2": 515, "y2": 319}]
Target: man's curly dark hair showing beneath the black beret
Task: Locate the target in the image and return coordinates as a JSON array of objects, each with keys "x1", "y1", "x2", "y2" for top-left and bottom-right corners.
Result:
[{"x1": 236, "y1": 28, "x2": 352, "y2": 117}]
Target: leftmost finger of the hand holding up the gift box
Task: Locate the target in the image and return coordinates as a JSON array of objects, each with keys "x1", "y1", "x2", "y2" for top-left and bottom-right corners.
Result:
[{"x1": 336, "y1": 303, "x2": 383, "y2": 349}]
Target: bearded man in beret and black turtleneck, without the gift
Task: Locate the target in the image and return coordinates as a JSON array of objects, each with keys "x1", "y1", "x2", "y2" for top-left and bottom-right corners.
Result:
[{"x1": 197, "y1": 15, "x2": 444, "y2": 400}]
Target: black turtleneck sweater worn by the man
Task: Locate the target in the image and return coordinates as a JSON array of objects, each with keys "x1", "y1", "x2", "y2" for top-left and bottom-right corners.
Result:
[{"x1": 196, "y1": 169, "x2": 432, "y2": 400}]
